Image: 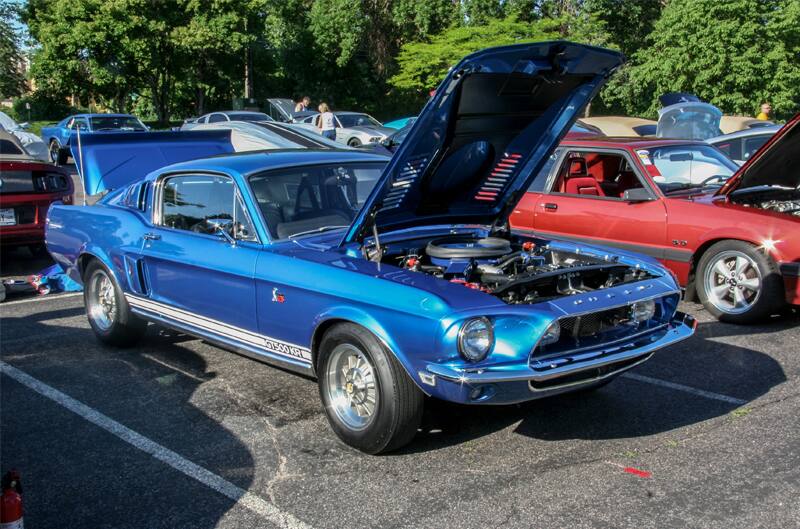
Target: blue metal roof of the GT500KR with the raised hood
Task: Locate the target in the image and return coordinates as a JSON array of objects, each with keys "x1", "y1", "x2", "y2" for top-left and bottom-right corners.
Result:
[{"x1": 148, "y1": 149, "x2": 389, "y2": 179}]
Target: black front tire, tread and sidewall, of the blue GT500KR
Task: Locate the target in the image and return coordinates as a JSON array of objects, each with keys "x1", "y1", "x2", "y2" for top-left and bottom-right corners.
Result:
[{"x1": 318, "y1": 323, "x2": 424, "y2": 454}]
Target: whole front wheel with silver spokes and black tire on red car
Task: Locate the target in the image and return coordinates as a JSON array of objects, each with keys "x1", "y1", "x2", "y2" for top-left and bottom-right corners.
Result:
[{"x1": 695, "y1": 240, "x2": 786, "y2": 324}]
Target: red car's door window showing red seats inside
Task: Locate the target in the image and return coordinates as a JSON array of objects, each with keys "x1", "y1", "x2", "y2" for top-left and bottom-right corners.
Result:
[{"x1": 551, "y1": 151, "x2": 644, "y2": 199}]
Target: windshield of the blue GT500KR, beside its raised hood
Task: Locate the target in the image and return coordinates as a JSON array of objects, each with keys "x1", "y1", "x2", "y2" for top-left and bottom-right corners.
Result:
[{"x1": 250, "y1": 162, "x2": 384, "y2": 239}]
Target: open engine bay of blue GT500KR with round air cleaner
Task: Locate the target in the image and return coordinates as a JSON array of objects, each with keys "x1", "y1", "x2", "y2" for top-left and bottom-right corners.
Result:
[{"x1": 380, "y1": 235, "x2": 654, "y2": 304}]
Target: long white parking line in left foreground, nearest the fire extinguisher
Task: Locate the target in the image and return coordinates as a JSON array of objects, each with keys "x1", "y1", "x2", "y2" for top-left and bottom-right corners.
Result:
[{"x1": 0, "y1": 361, "x2": 311, "y2": 529}]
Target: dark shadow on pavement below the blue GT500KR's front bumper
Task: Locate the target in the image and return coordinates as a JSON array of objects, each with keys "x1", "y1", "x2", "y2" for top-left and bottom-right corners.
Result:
[{"x1": 400, "y1": 315, "x2": 800, "y2": 453}]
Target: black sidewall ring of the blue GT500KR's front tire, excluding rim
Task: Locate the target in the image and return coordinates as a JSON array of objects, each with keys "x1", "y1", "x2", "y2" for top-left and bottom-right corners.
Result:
[{"x1": 318, "y1": 324, "x2": 404, "y2": 453}]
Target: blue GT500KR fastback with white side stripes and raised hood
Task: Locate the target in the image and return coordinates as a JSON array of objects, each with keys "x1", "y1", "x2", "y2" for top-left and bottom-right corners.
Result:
[{"x1": 47, "y1": 42, "x2": 695, "y2": 453}]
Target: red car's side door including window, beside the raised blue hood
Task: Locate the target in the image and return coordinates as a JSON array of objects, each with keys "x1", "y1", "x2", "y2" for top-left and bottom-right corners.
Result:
[{"x1": 531, "y1": 148, "x2": 667, "y2": 259}]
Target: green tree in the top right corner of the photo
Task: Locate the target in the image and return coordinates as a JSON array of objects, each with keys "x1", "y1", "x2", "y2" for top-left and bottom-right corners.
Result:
[{"x1": 605, "y1": 0, "x2": 800, "y2": 117}]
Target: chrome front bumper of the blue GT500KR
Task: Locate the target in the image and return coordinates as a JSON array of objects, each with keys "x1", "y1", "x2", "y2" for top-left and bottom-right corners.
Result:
[{"x1": 426, "y1": 312, "x2": 697, "y2": 391}]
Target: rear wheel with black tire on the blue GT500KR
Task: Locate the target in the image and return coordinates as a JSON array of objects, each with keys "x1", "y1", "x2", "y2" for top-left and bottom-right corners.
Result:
[{"x1": 83, "y1": 261, "x2": 147, "y2": 347}]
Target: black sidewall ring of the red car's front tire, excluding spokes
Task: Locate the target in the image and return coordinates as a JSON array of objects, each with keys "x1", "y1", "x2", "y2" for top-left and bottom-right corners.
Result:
[{"x1": 695, "y1": 240, "x2": 785, "y2": 324}]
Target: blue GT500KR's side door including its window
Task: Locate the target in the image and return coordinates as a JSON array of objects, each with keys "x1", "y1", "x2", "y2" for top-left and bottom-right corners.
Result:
[{"x1": 141, "y1": 174, "x2": 261, "y2": 333}]
